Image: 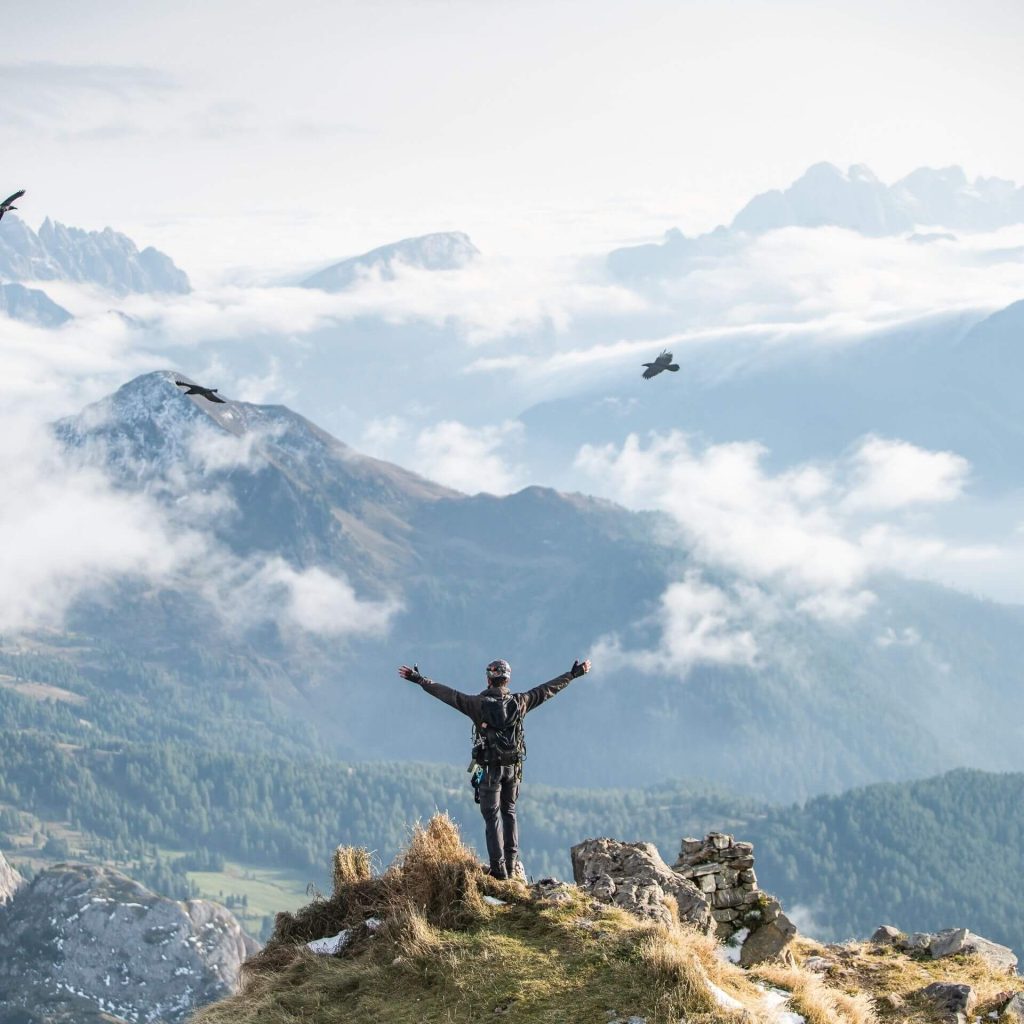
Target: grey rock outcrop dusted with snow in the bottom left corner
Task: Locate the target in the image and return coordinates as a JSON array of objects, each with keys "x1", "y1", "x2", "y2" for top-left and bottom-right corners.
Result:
[{"x1": 0, "y1": 864, "x2": 258, "y2": 1024}]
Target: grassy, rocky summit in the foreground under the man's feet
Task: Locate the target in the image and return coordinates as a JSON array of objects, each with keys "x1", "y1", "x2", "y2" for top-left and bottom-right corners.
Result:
[{"x1": 196, "y1": 815, "x2": 1024, "y2": 1024}]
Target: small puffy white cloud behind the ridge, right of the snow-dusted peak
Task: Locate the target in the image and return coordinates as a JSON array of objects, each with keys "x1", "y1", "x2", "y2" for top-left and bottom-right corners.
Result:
[{"x1": 414, "y1": 420, "x2": 524, "y2": 495}]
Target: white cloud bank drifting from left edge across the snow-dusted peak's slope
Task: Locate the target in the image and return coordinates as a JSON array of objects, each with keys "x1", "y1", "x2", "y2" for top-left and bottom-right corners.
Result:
[{"x1": 0, "y1": 417, "x2": 400, "y2": 636}]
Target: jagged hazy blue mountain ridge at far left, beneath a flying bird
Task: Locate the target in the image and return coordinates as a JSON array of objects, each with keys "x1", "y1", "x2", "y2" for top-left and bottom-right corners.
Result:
[{"x1": 0, "y1": 215, "x2": 189, "y2": 295}]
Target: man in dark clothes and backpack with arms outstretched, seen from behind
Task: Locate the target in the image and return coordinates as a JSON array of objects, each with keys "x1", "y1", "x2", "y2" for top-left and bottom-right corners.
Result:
[{"x1": 398, "y1": 660, "x2": 590, "y2": 879}]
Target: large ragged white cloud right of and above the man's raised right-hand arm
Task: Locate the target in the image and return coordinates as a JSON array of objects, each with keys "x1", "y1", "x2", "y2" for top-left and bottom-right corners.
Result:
[{"x1": 577, "y1": 432, "x2": 1007, "y2": 674}]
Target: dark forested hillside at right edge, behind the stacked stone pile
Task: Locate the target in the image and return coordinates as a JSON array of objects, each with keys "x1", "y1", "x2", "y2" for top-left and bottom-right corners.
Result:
[{"x1": 744, "y1": 770, "x2": 1024, "y2": 951}]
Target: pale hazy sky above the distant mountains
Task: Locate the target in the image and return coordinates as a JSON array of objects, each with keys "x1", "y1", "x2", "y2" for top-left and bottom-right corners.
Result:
[{"x1": 8, "y1": 0, "x2": 1024, "y2": 273}]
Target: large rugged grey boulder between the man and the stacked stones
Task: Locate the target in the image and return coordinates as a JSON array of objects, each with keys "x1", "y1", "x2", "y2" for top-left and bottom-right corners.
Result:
[{"x1": 570, "y1": 839, "x2": 715, "y2": 935}]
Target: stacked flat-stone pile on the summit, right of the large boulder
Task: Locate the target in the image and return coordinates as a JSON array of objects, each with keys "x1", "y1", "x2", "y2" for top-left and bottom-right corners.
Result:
[{"x1": 672, "y1": 833, "x2": 763, "y2": 938}]
